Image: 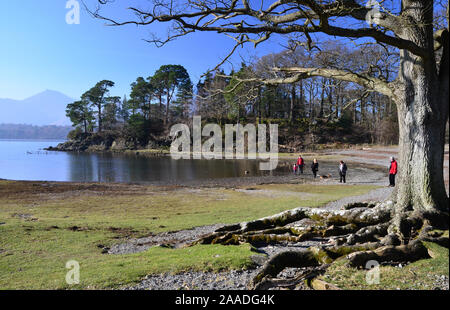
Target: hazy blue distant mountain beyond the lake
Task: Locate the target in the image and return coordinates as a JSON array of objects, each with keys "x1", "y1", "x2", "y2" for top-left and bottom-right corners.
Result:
[{"x1": 0, "y1": 90, "x2": 74, "y2": 126}]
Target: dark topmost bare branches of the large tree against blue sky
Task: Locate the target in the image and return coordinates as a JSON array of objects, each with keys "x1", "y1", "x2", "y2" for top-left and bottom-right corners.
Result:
[{"x1": 86, "y1": 0, "x2": 427, "y2": 57}]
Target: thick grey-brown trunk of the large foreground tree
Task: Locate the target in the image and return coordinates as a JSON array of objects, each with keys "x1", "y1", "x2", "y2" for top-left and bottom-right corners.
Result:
[{"x1": 395, "y1": 0, "x2": 448, "y2": 230}]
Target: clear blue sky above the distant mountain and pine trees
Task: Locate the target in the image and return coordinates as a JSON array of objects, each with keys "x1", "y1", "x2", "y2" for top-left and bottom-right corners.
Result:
[{"x1": 0, "y1": 0, "x2": 282, "y2": 100}]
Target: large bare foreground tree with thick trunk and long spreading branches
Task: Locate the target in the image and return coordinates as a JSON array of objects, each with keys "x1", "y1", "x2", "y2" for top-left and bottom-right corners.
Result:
[{"x1": 89, "y1": 0, "x2": 449, "y2": 288}]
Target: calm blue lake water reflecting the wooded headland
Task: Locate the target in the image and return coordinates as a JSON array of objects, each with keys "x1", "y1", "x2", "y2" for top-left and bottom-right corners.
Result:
[{"x1": 0, "y1": 139, "x2": 287, "y2": 183}]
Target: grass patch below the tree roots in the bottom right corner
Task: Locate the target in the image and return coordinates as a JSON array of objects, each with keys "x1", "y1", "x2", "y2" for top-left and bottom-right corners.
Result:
[{"x1": 320, "y1": 242, "x2": 449, "y2": 290}]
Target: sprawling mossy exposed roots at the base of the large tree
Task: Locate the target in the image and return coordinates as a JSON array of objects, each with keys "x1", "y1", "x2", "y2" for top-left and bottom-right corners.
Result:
[{"x1": 195, "y1": 201, "x2": 449, "y2": 289}]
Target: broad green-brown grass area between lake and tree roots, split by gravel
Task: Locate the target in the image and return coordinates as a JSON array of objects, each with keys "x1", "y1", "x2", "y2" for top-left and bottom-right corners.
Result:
[{"x1": 0, "y1": 181, "x2": 375, "y2": 289}]
